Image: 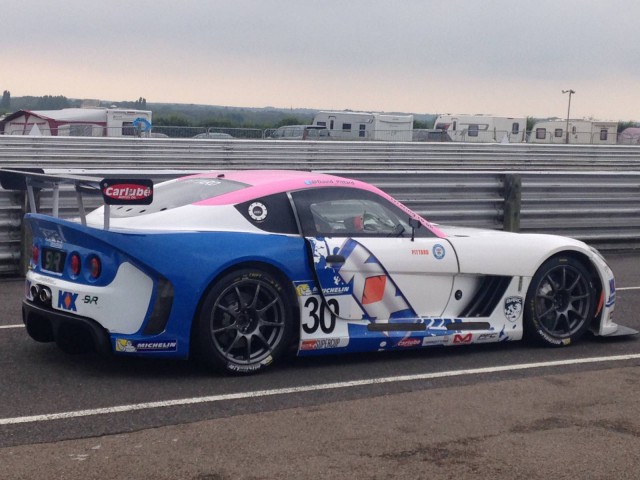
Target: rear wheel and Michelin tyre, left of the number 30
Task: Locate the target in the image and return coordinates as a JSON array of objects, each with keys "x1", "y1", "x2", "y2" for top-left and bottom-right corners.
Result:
[{"x1": 193, "y1": 269, "x2": 294, "y2": 375}]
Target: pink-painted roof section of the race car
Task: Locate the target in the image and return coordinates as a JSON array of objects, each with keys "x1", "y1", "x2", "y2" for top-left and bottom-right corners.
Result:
[{"x1": 178, "y1": 170, "x2": 381, "y2": 205}]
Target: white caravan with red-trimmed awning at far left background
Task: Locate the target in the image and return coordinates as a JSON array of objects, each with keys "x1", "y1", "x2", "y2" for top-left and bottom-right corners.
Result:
[{"x1": 0, "y1": 108, "x2": 152, "y2": 137}]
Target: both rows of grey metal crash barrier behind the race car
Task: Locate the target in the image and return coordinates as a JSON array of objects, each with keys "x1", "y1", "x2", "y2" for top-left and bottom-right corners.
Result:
[{"x1": 0, "y1": 136, "x2": 640, "y2": 275}]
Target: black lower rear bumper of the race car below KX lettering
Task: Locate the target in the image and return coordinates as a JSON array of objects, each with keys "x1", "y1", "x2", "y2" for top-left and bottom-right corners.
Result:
[{"x1": 22, "y1": 300, "x2": 111, "y2": 353}]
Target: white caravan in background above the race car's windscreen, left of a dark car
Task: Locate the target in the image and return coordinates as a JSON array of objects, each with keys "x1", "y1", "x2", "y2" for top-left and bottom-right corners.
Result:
[{"x1": 312, "y1": 111, "x2": 413, "y2": 142}]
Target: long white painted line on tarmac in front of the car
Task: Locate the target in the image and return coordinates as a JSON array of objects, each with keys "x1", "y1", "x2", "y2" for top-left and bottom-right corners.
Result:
[{"x1": 0, "y1": 354, "x2": 640, "y2": 425}]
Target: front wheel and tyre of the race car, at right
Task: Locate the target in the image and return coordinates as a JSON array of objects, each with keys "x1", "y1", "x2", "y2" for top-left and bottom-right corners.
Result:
[{"x1": 524, "y1": 255, "x2": 596, "y2": 347}]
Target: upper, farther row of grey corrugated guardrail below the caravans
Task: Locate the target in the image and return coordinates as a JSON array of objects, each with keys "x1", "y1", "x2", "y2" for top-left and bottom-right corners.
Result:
[{"x1": 0, "y1": 135, "x2": 640, "y2": 171}]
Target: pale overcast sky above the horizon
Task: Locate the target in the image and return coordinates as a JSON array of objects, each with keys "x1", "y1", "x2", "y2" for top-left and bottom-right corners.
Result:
[{"x1": 5, "y1": 0, "x2": 640, "y2": 121}]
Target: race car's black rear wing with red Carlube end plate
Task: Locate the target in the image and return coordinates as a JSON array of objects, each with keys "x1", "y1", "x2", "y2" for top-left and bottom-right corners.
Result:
[{"x1": 0, "y1": 168, "x2": 153, "y2": 230}]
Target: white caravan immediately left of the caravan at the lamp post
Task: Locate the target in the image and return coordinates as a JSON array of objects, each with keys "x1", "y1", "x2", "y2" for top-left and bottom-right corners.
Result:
[{"x1": 434, "y1": 115, "x2": 527, "y2": 143}]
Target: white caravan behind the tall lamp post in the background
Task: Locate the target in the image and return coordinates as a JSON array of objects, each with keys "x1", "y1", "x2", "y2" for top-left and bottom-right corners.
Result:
[{"x1": 528, "y1": 119, "x2": 618, "y2": 145}]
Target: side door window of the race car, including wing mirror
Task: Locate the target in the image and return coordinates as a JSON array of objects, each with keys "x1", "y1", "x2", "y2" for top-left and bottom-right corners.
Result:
[{"x1": 292, "y1": 187, "x2": 433, "y2": 237}]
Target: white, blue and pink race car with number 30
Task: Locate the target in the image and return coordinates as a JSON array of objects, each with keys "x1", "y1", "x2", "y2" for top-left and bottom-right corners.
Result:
[{"x1": 5, "y1": 170, "x2": 637, "y2": 374}]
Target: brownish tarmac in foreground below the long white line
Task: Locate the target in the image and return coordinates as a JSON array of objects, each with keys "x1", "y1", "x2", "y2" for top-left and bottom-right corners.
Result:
[{"x1": 0, "y1": 364, "x2": 640, "y2": 480}]
